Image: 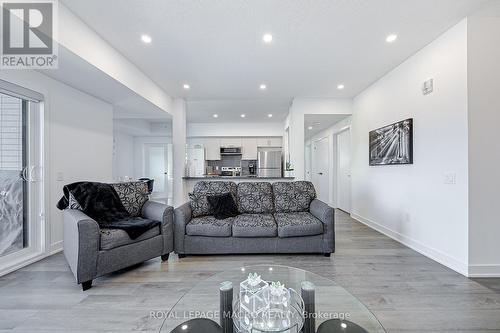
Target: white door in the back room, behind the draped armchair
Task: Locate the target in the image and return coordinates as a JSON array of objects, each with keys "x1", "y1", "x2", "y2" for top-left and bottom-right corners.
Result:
[{"x1": 144, "y1": 143, "x2": 172, "y2": 200}]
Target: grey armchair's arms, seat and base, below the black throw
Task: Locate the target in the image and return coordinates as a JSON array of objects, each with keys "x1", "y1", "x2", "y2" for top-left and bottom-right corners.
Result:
[{"x1": 63, "y1": 201, "x2": 174, "y2": 291}]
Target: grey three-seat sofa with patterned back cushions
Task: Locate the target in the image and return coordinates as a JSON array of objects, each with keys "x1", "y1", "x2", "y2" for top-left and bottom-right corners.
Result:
[{"x1": 174, "y1": 181, "x2": 335, "y2": 258}]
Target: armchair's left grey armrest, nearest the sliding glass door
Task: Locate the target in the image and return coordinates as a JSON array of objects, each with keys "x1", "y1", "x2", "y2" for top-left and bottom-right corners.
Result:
[{"x1": 63, "y1": 209, "x2": 100, "y2": 283}]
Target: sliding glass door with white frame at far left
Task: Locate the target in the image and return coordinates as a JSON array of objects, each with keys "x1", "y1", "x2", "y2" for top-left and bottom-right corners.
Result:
[{"x1": 0, "y1": 81, "x2": 43, "y2": 273}]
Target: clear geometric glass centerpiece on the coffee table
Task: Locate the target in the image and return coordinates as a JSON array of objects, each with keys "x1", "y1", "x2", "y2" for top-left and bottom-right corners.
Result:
[{"x1": 233, "y1": 273, "x2": 304, "y2": 333}]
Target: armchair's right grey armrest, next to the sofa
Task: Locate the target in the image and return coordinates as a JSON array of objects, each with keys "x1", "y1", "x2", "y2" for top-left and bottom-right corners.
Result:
[{"x1": 142, "y1": 200, "x2": 174, "y2": 255}]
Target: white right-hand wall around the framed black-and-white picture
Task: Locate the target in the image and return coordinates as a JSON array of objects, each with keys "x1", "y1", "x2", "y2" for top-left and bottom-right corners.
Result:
[{"x1": 351, "y1": 20, "x2": 468, "y2": 274}]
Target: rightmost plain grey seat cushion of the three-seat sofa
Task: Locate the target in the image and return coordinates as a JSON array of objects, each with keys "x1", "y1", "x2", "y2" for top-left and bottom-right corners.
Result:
[{"x1": 274, "y1": 212, "x2": 323, "y2": 238}]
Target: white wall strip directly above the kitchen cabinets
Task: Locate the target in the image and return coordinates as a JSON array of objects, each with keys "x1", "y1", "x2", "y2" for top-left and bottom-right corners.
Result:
[{"x1": 187, "y1": 122, "x2": 283, "y2": 137}]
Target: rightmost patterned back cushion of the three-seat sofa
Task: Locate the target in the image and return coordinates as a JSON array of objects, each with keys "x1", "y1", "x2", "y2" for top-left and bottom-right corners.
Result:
[{"x1": 273, "y1": 181, "x2": 316, "y2": 213}]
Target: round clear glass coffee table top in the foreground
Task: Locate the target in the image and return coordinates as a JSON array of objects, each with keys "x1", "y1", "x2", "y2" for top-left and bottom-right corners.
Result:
[{"x1": 161, "y1": 265, "x2": 385, "y2": 333}]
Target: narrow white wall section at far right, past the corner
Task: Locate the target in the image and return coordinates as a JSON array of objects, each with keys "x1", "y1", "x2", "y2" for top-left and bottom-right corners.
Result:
[{"x1": 468, "y1": 14, "x2": 500, "y2": 277}]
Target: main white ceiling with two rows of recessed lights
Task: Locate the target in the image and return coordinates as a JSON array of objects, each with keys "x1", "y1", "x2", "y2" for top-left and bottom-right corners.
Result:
[{"x1": 62, "y1": 0, "x2": 487, "y2": 121}]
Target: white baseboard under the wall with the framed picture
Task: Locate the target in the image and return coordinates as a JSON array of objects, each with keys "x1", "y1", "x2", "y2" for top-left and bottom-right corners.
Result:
[{"x1": 351, "y1": 213, "x2": 470, "y2": 276}]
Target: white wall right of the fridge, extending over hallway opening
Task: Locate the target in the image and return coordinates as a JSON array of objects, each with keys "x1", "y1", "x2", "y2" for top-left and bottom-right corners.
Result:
[{"x1": 282, "y1": 98, "x2": 352, "y2": 180}]
